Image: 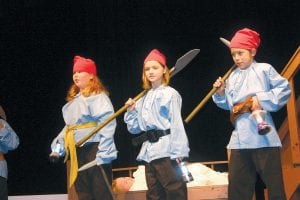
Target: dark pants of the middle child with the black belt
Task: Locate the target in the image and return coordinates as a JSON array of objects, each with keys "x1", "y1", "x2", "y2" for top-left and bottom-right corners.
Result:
[{"x1": 145, "y1": 158, "x2": 187, "y2": 200}]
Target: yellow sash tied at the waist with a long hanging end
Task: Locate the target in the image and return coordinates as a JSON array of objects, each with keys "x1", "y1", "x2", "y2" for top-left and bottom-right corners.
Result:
[{"x1": 64, "y1": 122, "x2": 97, "y2": 187}]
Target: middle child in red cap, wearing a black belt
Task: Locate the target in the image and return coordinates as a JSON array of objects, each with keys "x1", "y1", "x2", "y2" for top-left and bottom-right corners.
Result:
[{"x1": 124, "y1": 49, "x2": 189, "y2": 200}]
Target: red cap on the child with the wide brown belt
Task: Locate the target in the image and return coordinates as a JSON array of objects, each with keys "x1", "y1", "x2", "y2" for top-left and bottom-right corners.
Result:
[{"x1": 229, "y1": 28, "x2": 260, "y2": 49}]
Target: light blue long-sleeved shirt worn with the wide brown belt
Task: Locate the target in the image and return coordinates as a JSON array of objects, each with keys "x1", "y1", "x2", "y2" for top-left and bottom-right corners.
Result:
[{"x1": 213, "y1": 61, "x2": 291, "y2": 149}]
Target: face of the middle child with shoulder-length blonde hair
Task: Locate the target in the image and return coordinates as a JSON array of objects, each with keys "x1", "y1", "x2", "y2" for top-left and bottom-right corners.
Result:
[{"x1": 144, "y1": 61, "x2": 166, "y2": 88}]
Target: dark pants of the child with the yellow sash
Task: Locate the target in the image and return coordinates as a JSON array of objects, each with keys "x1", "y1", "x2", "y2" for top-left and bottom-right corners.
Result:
[{"x1": 75, "y1": 143, "x2": 113, "y2": 200}]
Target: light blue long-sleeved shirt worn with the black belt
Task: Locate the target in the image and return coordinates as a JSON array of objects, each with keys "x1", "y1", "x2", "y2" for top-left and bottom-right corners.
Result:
[{"x1": 124, "y1": 85, "x2": 190, "y2": 163}]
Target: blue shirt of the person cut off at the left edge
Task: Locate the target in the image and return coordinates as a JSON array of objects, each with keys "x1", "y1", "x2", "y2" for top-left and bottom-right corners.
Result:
[{"x1": 0, "y1": 119, "x2": 19, "y2": 178}]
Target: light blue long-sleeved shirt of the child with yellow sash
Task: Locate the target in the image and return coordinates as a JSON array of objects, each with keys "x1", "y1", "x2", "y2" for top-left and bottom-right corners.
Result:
[{"x1": 51, "y1": 93, "x2": 117, "y2": 165}]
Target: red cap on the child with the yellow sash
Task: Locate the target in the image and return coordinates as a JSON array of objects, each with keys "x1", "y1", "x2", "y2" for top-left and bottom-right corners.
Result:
[{"x1": 73, "y1": 56, "x2": 97, "y2": 75}]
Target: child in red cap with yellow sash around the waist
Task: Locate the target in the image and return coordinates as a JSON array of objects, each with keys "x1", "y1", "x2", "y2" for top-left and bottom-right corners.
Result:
[{"x1": 50, "y1": 56, "x2": 117, "y2": 200}]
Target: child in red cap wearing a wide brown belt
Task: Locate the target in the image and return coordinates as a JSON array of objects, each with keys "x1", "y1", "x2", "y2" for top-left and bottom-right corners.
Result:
[{"x1": 213, "y1": 28, "x2": 291, "y2": 200}]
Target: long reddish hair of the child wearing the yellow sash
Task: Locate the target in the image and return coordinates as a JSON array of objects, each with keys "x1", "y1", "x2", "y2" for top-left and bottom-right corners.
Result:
[{"x1": 66, "y1": 75, "x2": 109, "y2": 102}]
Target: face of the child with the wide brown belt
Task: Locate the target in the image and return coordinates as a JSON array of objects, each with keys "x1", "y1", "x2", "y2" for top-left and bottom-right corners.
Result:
[{"x1": 231, "y1": 48, "x2": 256, "y2": 69}]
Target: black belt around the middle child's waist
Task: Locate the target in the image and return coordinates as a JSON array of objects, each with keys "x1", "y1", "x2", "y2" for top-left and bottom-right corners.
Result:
[{"x1": 132, "y1": 129, "x2": 170, "y2": 146}]
